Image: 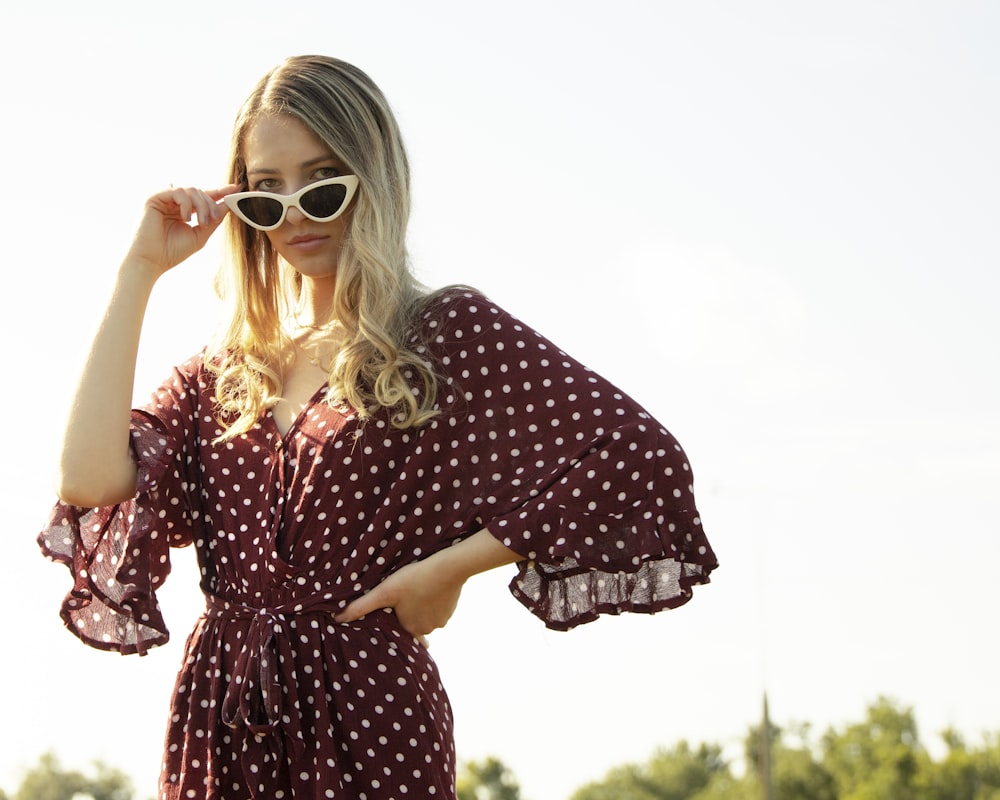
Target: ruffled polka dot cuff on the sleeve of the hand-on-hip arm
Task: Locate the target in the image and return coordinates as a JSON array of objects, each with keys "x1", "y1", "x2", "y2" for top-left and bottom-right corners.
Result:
[{"x1": 491, "y1": 503, "x2": 718, "y2": 631}]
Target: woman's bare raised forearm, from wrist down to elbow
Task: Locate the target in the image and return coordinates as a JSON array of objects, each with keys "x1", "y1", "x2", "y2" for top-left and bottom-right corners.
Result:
[{"x1": 56, "y1": 259, "x2": 157, "y2": 506}]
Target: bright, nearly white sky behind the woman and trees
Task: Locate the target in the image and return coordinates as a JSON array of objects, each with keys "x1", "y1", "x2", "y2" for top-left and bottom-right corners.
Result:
[{"x1": 0, "y1": 0, "x2": 1000, "y2": 800}]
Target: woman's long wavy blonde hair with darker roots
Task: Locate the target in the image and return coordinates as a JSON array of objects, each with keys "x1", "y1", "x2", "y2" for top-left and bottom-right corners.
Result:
[{"x1": 207, "y1": 56, "x2": 437, "y2": 440}]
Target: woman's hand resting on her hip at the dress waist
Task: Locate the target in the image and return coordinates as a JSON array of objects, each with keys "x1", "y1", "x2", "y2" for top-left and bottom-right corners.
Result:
[{"x1": 336, "y1": 553, "x2": 465, "y2": 639}]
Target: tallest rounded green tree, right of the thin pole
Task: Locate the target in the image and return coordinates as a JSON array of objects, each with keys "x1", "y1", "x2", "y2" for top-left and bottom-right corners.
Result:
[{"x1": 822, "y1": 697, "x2": 929, "y2": 800}]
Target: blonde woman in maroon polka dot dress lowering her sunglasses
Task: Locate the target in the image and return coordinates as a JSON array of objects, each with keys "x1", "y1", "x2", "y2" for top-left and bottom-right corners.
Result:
[{"x1": 40, "y1": 57, "x2": 715, "y2": 800}]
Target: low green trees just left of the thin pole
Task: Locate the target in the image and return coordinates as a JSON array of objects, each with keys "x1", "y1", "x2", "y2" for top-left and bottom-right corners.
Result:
[{"x1": 572, "y1": 741, "x2": 729, "y2": 800}]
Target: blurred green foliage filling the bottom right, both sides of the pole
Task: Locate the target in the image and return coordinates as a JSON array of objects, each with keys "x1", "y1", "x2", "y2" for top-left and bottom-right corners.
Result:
[{"x1": 571, "y1": 697, "x2": 1000, "y2": 800}]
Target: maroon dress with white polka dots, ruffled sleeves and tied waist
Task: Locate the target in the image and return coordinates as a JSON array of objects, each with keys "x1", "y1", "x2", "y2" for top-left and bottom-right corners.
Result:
[{"x1": 39, "y1": 290, "x2": 716, "y2": 800}]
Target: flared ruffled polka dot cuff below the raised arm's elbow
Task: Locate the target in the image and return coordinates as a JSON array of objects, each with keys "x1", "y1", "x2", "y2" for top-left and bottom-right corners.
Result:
[{"x1": 38, "y1": 412, "x2": 189, "y2": 655}]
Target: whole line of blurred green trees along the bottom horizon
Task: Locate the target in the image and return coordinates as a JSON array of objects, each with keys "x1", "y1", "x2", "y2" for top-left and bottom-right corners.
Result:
[{"x1": 0, "y1": 697, "x2": 1000, "y2": 800}]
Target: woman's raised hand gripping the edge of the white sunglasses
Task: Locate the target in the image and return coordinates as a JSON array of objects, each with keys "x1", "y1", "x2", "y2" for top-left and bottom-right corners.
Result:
[{"x1": 126, "y1": 184, "x2": 240, "y2": 277}]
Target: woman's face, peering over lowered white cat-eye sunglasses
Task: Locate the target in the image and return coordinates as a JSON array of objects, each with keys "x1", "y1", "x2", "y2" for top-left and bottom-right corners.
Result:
[{"x1": 244, "y1": 115, "x2": 351, "y2": 279}]
